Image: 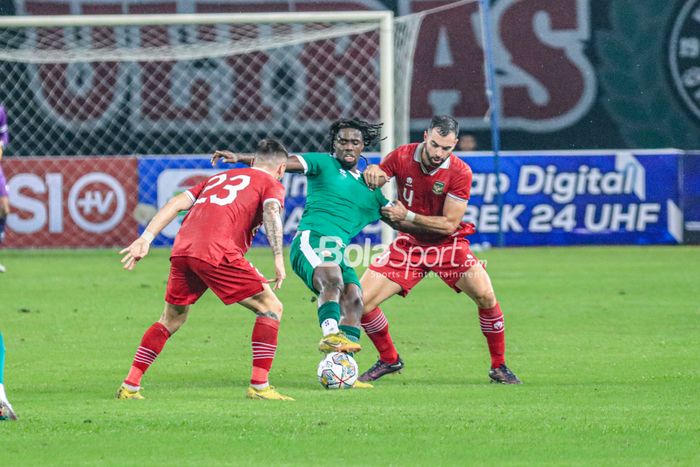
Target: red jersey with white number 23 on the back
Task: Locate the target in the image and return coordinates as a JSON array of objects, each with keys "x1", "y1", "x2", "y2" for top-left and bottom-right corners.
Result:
[{"x1": 171, "y1": 168, "x2": 284, "y2": 266}]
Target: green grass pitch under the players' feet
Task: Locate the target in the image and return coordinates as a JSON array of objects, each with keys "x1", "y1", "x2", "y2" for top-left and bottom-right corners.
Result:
[{"x1": 0, "y1": 247, "x2": 700, "y2": 466}]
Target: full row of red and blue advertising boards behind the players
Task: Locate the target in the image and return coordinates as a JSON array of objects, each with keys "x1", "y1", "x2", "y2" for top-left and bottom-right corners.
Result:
[{"x1": 5, "y1": 150, "x2": 700, "y2": 247}]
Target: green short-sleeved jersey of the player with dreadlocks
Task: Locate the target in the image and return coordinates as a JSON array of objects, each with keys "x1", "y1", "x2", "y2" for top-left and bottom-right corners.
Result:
[{"x1": 297, "y1": 153, "x2": 389, "y2": 245}]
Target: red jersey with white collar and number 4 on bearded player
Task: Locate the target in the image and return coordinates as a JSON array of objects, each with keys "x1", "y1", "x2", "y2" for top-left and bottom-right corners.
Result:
[{"x1": 380, "y1": 143, "x2": 472, "y2": 243}]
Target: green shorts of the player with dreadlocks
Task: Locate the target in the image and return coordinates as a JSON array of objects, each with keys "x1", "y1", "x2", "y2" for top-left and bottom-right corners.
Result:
[{"x1": 289, "y1": 230, "x2": 360, "y2": 295}]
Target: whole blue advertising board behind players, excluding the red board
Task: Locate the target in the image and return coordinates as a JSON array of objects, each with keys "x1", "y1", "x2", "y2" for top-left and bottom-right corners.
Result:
[{"x1": 139, "y1": 150, "x2": 683, "y2": 250}]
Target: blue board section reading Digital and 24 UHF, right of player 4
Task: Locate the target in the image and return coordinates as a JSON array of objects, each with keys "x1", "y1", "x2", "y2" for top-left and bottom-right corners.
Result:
[{"x1": 462, "y1": 150, "x2": 683, "y2": 246}]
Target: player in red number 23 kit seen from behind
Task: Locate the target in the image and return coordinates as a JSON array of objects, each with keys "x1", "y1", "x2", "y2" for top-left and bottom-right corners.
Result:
[{"x1": 117, "y1": 139, "x2": 291, "y2": 400}]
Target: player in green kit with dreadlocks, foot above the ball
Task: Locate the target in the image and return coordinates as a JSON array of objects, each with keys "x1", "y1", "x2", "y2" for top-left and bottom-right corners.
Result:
[{"x1": 212, "y1": 119, "x2": 389, "y2": 364}]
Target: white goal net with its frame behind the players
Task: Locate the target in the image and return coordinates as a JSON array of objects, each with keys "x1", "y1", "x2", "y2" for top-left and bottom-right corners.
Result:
[{"x1": 0, "y1": 11, "x2": 434, "y2": 247}]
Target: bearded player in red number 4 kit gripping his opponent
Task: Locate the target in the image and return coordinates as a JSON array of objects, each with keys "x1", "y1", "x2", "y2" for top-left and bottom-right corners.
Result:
[{"x1": 359, "y1": 116, "x2": 520, "y2": 384}]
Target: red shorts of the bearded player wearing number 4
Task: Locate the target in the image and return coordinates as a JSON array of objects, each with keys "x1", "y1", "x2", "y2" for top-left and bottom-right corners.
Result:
[{"x1": 369, "y1": 236, "x2": 479, "y2": 297}]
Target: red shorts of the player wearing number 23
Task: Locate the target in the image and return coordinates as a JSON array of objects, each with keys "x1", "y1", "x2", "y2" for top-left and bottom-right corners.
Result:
[{"x1": 165, "y1": 256, "x2": 267, "y2": 305}]
